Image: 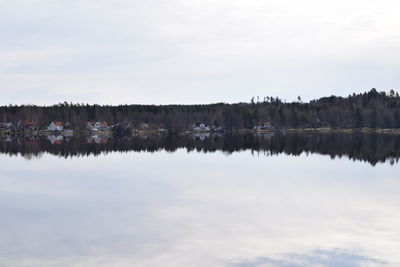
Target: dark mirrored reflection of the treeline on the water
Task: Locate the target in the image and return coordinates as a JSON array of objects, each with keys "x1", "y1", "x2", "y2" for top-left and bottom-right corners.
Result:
[{"x1": 0, "y1": 133, "x2": 400, "y2": 165}]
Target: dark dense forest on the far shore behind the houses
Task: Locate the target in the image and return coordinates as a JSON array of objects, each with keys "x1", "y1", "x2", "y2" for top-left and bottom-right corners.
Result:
[{"x1": 0, "y1": 89, "x2": 400, "y2": 133}]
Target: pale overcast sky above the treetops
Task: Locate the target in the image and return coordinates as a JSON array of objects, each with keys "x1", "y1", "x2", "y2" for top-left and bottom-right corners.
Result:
[{"x1": 0, "y1": 0, "x2": 400, "y2": 105}]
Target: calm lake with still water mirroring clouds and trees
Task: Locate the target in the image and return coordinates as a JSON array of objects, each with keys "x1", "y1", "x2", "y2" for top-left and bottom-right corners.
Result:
[{"x1": 0, "y1": 133, "x2": 400, "y2": 267}]
